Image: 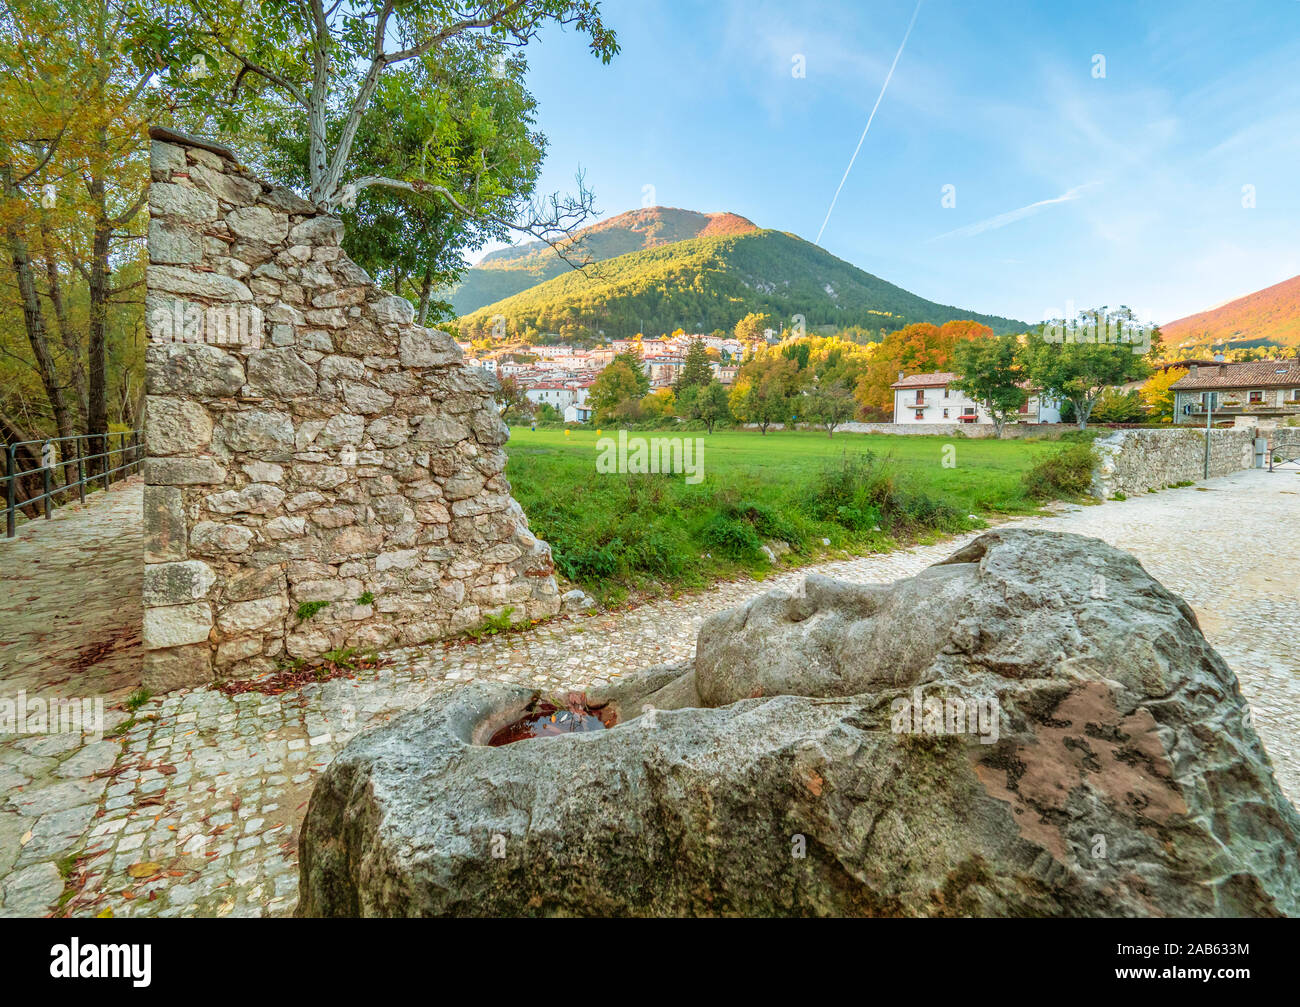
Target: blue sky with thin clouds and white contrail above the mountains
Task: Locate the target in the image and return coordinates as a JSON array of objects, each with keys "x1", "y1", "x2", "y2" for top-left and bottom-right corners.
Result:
[{"x1": 483, "y1": 0, "x2": 1300, "y2": 322}]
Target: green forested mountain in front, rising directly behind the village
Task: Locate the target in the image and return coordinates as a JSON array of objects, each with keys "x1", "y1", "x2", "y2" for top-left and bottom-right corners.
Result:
[{"x1": 460, "y1": 230, "x2": 1027, "y2": 339}]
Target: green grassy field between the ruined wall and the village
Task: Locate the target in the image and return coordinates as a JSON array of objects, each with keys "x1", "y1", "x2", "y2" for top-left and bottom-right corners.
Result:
[{"x1": 506, "y1": 426, "x2": 1062, "y2": 603}]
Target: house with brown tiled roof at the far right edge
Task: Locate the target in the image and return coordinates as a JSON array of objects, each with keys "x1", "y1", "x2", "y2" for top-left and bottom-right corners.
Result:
[{"x1": 1170, "y1": 360, "x2": 1300, "y2": 430}]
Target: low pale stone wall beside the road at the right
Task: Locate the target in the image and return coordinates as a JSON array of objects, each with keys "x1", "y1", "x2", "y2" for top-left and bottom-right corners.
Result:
[{"x1": 1092, "y1": 427, "x2": 1255, "y2": 499}]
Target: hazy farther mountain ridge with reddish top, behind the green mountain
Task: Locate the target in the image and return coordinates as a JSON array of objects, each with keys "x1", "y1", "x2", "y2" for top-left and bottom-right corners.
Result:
[{"x1": 447, "y1": 207, "x2": 758, "y2": 314}]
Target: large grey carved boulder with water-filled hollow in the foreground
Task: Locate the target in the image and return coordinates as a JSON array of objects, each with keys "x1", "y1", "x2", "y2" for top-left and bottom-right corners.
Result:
[{"x1": 298, "y1": 530, "x2": 1300, "y2": 916}]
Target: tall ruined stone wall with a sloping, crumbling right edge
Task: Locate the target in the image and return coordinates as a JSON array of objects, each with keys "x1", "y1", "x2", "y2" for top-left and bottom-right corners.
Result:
[{"x1": 144, "y1": 130, "x2": 559, "y2": 691}]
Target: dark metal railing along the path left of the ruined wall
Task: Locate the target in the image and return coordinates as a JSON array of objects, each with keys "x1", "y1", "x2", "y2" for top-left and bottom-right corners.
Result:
[{"x1": 0, "y1": 430, "x2": 144, "y2": 538}]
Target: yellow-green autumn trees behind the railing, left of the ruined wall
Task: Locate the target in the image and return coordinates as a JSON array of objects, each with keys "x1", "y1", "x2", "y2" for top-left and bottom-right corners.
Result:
[{"x1": 0, "y1": 0, "x2": 149, "y2": 488}]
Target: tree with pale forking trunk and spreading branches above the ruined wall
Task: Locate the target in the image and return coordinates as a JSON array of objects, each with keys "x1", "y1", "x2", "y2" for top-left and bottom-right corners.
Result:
[{"x1": 144, "y1": 0, "x2": 619, "y2": 214}]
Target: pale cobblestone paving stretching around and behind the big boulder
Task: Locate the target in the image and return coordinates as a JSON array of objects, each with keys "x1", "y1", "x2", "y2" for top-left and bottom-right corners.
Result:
[{"x1": 0, "y1": 470, "x2": 1300, "y2": 916}]
